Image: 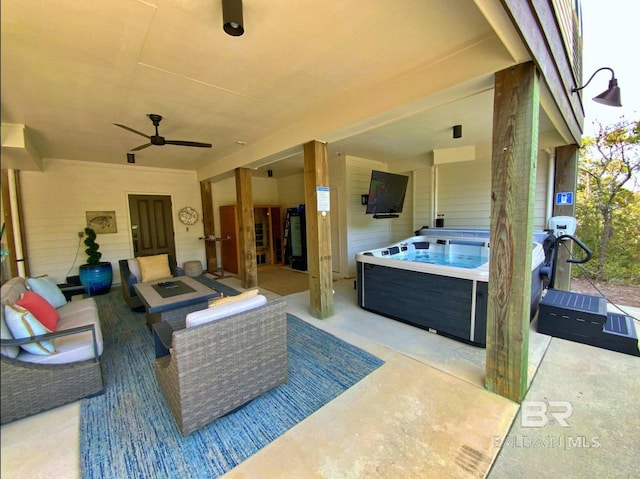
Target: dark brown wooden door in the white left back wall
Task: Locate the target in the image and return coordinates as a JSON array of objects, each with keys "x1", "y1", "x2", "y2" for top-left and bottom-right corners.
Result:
[{"x1": 129, "y1": 195, "x2": 176, "y2": 259}]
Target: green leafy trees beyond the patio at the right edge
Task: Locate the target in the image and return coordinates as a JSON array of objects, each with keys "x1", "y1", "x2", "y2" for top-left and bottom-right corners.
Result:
[{"x1": 576, "y1": 117, "x2": 640, "y2": 281}]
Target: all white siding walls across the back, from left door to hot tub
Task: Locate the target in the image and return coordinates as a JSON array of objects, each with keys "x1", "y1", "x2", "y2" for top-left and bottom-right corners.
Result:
[{"x1": 11, "y1": 148, "x2": 549, "y2": 284}]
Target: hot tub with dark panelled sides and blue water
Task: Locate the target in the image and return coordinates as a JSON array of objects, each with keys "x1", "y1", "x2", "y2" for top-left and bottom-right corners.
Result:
[{"x1": 356, "y1": 230, "x2": 545, "y2": 347}]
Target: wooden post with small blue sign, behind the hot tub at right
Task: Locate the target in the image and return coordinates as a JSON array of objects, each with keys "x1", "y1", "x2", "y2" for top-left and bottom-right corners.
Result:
[{"x1": 553, "y1": 145, "x2": 579, "y2": 291}]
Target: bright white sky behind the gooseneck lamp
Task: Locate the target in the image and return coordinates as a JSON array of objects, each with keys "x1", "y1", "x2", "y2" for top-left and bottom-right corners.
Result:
[{"x1": 581, "y1": 0, "x2": 640, "y2": 136}]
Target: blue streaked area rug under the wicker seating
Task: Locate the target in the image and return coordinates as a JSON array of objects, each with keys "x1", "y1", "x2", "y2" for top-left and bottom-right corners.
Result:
[{"x1": 80, "y1": 280, "x2": 383, "y2": 478}]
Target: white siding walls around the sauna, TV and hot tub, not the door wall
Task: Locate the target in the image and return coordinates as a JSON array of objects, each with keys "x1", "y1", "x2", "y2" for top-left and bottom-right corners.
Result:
[{"x1": 202, "y1": 147, "x2": 548, "y2": 277}]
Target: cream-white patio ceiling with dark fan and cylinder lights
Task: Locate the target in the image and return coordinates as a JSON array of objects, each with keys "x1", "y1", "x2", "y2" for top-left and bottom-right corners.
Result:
[{"x1": 1, "y1": 0, "x2": 550, "y2": 179}]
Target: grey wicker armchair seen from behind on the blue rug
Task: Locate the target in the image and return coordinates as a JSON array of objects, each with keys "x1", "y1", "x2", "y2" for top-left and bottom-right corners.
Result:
[{"x1": 154, "y1": 300, "x2": 288, "y2": 436}]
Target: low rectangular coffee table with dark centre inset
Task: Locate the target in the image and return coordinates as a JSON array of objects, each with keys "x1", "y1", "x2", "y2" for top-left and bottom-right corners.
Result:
[{"x1": 133, "y1": 276, "x2": 222, "y2": 329}]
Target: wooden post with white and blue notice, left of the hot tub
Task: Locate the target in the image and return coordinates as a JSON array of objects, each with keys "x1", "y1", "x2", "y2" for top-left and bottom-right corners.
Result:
[{"x1": 304, "y1": 140, "x2": 333, "y2": 319}]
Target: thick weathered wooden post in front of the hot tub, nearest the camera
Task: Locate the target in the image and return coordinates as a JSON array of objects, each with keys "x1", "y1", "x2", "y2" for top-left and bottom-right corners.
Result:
[{"x1": 485, "y1": 62, "x2": 539, "y2": 402}]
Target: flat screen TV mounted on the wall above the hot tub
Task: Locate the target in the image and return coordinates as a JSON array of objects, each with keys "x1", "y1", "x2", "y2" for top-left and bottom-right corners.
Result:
[{"x1": 367, "y1": 170, "x2": 409, "y2": 218}]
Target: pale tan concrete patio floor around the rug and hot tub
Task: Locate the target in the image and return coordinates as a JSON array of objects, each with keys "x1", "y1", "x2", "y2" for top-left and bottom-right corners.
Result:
[{"x1": 1, "y1": 278, "x2": 640, "y2": 479}]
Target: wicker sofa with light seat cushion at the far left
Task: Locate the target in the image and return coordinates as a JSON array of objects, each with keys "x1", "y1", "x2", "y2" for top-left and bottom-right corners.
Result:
[{"x1": 0, "y1": 277, "x2": 104, "y2": 424}]
